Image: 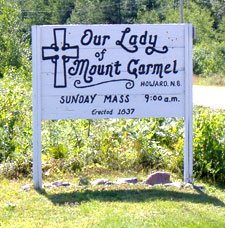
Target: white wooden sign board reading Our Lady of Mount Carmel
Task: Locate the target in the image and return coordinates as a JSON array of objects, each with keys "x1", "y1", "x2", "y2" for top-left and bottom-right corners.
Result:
[{"x1": 32, "y1": 24, "x2": 192, "y2": 187}]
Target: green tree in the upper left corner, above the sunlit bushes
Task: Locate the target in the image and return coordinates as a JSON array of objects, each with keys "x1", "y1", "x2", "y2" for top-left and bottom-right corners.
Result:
[{"x1": 0, "y1": 1, "x2": 30, "y2": 77}]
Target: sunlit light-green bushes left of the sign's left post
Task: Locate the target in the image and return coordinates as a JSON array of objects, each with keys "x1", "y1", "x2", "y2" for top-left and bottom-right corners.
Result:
[{"x1": 0, "y1": 68, "x2": 32, "y2": 176}]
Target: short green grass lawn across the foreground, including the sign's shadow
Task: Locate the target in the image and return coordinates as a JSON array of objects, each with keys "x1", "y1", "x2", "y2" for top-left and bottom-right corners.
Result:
[{"x1": 0, "y1": 174, "x2": 225, "y2": 228}]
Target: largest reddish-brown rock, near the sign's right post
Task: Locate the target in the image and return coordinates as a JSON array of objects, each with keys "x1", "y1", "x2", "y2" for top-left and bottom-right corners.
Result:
[{"x1": 145, "y1": 172, "x2": 170, "y2": 185}]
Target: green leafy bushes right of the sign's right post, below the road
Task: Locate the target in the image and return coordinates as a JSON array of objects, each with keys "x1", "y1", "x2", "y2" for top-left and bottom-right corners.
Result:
[{"x1": 193, "y1": 109, "x2": 225, "y2": 181}]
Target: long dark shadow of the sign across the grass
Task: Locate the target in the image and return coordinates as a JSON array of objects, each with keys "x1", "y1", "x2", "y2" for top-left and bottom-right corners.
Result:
[{"x1": 39, "y1": 189, "x2": 225, "y2": 207}]
